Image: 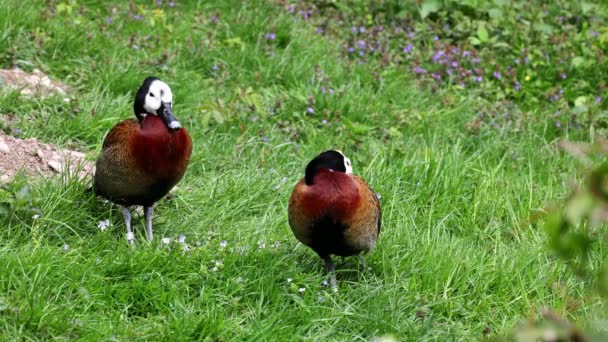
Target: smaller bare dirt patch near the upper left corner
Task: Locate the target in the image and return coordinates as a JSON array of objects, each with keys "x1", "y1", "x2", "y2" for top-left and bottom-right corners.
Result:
[{"x1": 0, "y1": 68, "x2": 69, "y2": 97}]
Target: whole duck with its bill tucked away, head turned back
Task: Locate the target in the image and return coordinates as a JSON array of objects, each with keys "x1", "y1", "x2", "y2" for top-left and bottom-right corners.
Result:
[{"x1": 288, "y1": 150, "x2": 382, "y2": 291}]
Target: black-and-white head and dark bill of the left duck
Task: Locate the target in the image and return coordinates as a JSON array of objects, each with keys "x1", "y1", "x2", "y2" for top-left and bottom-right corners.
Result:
[{"x1": 134, "y1": 77, "x2": 182, "y2": 131}]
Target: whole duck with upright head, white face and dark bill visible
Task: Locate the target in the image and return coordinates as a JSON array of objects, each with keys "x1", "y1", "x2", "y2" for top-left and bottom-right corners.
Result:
[{"x1": 93, "y1": 77, "x2": 192, "y2": 243}]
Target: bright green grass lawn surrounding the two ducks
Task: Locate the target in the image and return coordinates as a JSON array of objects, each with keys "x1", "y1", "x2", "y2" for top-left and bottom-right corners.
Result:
[{"x1": 0, "y1": 0, "x2": 608, "y2": 341}]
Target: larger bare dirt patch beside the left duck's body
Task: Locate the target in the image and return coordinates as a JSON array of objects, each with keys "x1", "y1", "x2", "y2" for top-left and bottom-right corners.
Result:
[{"x1": 0, "y1": 131, "x2": 95, "y2": 183}]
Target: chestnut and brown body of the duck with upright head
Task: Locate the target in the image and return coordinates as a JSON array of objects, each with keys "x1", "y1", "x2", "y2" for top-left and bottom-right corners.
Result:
[{"x1": 94, "y1": 115, "x2": 192, "y2": 206}]
